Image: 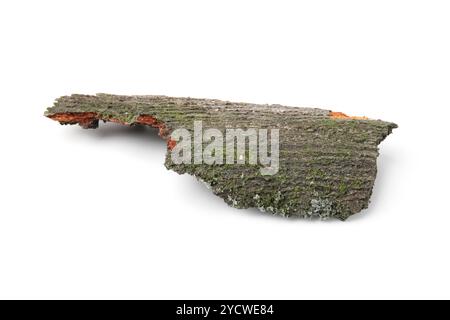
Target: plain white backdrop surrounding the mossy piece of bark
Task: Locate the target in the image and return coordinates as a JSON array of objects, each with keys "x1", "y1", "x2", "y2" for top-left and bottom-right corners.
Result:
[{"x1": 0, "y1": 0, "x2": 450, "y2": 299}]
